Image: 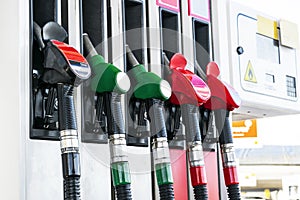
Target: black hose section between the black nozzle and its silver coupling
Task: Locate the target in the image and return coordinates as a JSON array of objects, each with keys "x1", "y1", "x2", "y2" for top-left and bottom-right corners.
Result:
[{"x1": 57, "y1": 84, "x2": 77, "y2": 131}]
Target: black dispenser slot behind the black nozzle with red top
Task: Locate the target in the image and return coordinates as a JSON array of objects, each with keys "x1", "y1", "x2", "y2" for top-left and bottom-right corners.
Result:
[{"x1": 30, "y1": 0, "x2": 61, "y2": 140}]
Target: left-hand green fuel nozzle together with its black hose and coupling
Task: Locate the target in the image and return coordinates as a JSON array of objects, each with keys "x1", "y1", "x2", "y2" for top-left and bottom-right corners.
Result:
[{"x1": 83, "y1": 34, "x2": 132, "y2": 200}]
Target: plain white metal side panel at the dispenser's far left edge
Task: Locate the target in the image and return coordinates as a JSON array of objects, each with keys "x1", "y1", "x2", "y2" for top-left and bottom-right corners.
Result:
[{"x1": 0, "y1": 0, "x2": 24, "y2": 199}]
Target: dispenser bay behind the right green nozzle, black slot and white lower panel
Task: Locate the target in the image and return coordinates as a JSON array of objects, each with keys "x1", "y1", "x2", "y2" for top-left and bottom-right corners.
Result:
[{"x1": 119, "y1": 0, "x2": 153, "y2": 200}]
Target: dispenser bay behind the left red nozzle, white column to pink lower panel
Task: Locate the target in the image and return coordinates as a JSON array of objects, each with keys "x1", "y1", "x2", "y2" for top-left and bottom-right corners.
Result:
[{"x1": 147, "y1": 0, "x2": 188, "y2": 198}]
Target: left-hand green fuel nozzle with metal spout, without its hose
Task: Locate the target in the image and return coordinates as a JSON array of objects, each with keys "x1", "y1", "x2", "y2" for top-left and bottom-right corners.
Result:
[{"x1": 83, "y1": 34, "x2": 130, "y2": 94}]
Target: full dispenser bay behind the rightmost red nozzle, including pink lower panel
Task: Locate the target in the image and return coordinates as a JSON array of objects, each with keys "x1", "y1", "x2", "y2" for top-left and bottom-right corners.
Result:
[{"x1": 181, "y1": 0, "x2": 219, "y2": 199}]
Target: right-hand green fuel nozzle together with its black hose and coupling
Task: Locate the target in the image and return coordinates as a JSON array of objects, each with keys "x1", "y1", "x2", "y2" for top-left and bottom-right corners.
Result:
[{"x1": 126, "y1": 46, "x2": 174, "y2": 200}]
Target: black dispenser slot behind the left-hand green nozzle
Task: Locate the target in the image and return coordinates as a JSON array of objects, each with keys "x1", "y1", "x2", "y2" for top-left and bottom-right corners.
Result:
[{"x1": 81, "y1": 0, "x2": 110, "y2": 144}]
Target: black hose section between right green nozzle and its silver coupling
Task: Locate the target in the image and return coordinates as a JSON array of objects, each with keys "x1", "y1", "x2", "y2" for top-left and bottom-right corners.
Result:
[{"x1": 147, "y1": 99, "x2": 167, "y2": 138}]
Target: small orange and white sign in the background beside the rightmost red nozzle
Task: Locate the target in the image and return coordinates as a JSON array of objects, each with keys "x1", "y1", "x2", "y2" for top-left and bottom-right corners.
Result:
[{"x1": 232, "y1": 119, "x2": 257, "y2": 138}]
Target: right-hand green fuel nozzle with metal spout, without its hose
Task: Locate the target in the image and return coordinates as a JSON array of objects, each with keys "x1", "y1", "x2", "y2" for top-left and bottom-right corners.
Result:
[{"x1": 126, "y1": 45, "x2": 172, "y2": 101}]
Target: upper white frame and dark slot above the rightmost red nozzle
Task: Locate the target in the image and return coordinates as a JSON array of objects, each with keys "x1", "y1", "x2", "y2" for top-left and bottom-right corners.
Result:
[{"x1": 181, "y1": 0, "x2": 213, "y2": 72}]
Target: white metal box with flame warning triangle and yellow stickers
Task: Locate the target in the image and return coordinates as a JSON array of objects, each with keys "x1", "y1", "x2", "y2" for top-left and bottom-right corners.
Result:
[{"x1": 212, "y1": 1, "x2": 300, "y2": 118}]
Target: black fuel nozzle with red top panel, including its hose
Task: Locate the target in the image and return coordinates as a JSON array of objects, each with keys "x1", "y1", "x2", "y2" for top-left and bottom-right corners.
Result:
[{"x1": 34, "y1": 22, "x2": 91, "y2": 200}]
